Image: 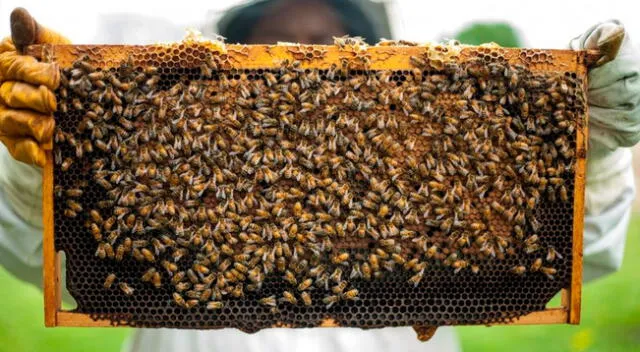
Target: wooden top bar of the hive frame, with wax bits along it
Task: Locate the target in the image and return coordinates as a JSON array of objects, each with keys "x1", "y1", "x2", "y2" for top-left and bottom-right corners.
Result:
[{"x1": 26, "y1": 41, "x2": 600, "y2": 75}]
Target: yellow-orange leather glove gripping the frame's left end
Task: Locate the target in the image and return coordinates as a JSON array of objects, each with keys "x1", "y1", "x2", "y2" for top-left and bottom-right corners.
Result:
[{"x1": 0, "y1": 8, "x2": 70, "y2": 167}]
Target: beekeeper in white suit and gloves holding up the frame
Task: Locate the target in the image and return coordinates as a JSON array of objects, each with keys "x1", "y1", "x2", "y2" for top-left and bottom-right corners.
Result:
[{"x1": 0, "y1": 0, "x2": 640, "y2": 352}]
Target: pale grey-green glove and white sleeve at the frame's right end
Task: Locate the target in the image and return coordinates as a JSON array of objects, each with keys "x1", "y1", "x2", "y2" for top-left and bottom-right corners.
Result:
[{"x1": 569, "y1": 21, "x2": 640, "y2": 280}]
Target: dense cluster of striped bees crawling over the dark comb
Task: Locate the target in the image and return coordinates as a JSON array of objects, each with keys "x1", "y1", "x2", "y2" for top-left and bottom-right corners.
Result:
[{"x1": 54, "y1": 38, "x2": 584, "y2": 310}]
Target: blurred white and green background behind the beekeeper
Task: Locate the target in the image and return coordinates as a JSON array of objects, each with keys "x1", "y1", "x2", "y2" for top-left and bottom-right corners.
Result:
[{"x1": 0, "y1": 0, "x2": 640, "y2": 352}]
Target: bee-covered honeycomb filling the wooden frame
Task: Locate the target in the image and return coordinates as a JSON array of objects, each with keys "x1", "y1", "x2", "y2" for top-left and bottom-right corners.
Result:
[{"x1": 42, "y1": 38, "x2": 586, "y2": 332}]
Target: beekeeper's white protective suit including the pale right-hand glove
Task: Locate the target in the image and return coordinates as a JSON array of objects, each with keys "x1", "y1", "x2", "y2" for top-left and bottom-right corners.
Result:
[{"x1": 0, "y1": 21, "x2": 640, "y2": 352}]
